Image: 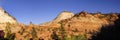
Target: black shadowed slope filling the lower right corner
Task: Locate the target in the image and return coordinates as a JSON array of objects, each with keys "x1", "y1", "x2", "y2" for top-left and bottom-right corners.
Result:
[{"x1": 91, "y1": 15, "x2": 120, "y2": 40}]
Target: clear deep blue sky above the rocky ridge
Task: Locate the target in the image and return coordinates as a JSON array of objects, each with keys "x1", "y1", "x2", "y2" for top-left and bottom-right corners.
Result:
[{"x1": 0, "y1": 0, "x2": 120, "y2": 24}]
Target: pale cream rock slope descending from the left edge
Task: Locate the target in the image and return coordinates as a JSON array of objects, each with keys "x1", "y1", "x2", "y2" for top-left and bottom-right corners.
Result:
[{"x1": 0, "y1": 7, "x2": 17, "y2": 24}]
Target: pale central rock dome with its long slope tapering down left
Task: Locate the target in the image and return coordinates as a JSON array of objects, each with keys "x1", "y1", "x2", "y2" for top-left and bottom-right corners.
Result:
[{"x1": 40, "y1": 11, "x2": 74, "y2": 26}]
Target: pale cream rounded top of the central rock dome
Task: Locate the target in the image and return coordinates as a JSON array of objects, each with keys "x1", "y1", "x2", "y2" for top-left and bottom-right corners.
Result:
[{"x1": 53, "y1": 11, "x2": 74, "y2": 22}]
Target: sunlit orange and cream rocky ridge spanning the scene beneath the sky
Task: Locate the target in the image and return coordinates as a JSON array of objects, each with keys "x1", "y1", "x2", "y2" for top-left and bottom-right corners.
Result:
[{"x1": 0, "y1": 8, "x2": 120, "y2": 40}]
